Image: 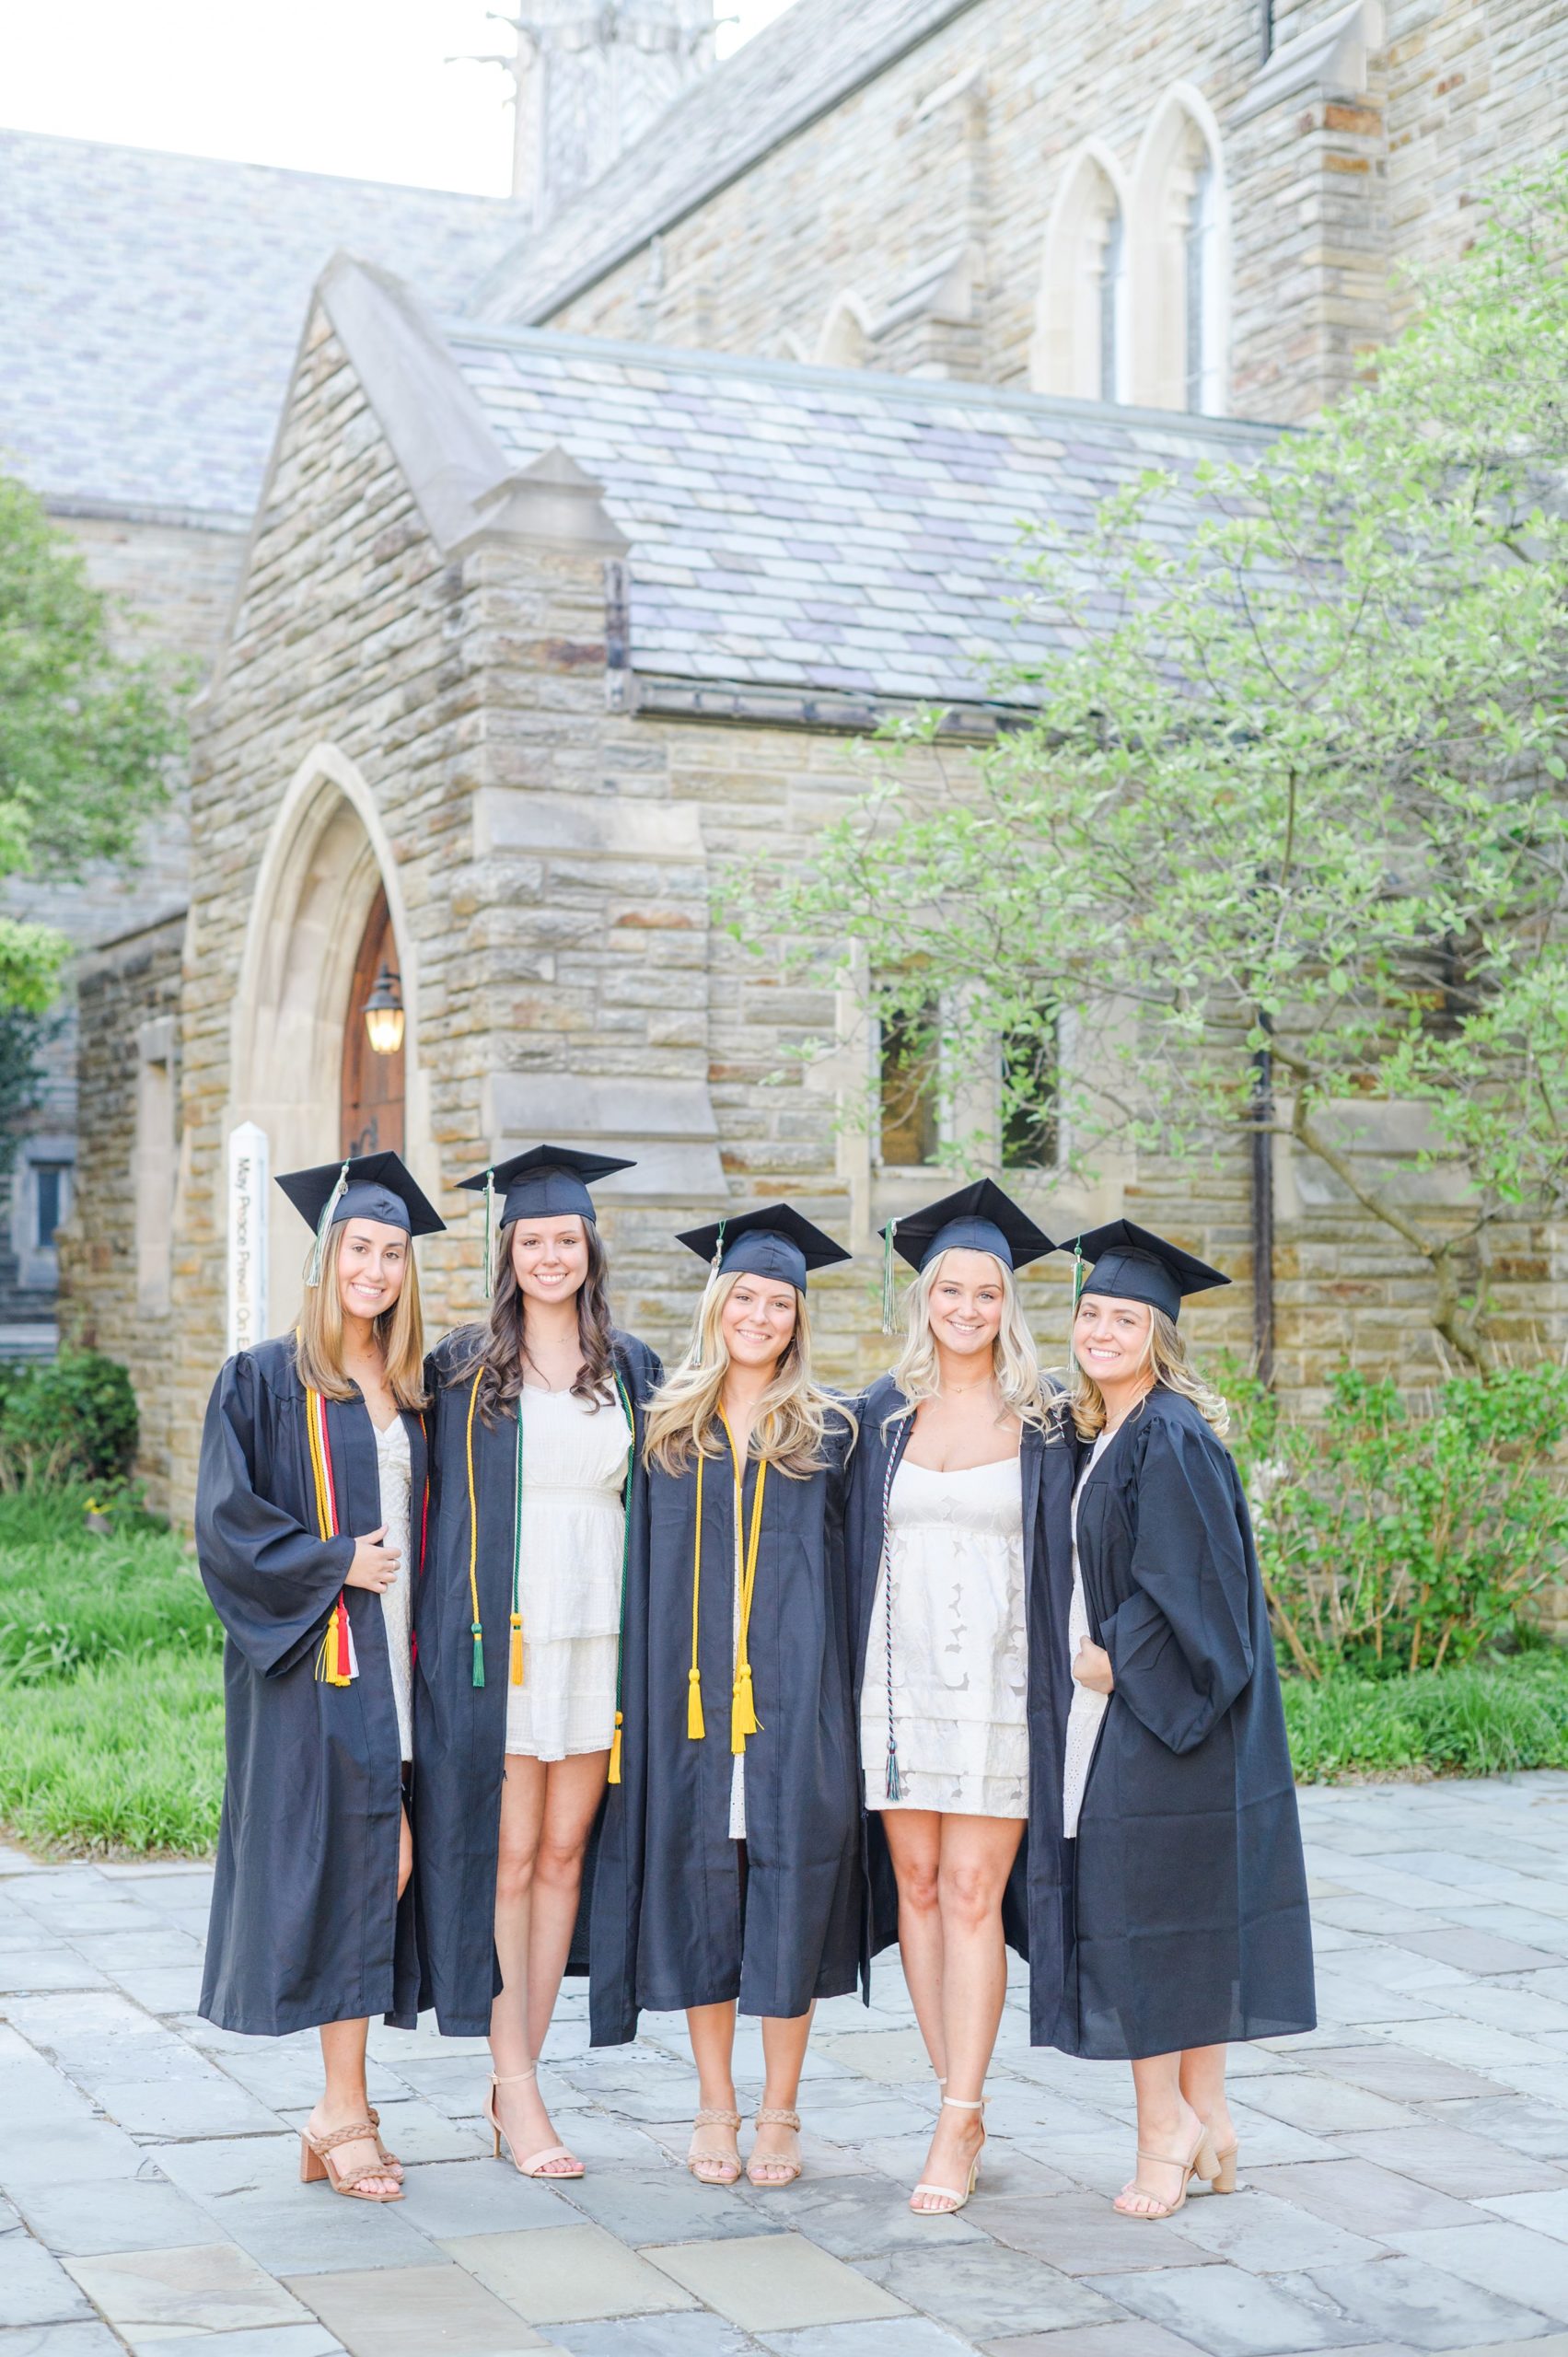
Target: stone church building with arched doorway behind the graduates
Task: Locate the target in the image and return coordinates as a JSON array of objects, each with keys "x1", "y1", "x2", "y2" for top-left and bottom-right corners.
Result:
[{"x1": 6, "y1": 0, "x2": 1568, "y2": 1502}]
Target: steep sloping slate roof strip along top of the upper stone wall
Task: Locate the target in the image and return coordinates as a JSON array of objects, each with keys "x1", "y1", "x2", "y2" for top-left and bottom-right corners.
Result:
[{"x1": 476, "y1": 0, "x2": 976, "y2": 325}]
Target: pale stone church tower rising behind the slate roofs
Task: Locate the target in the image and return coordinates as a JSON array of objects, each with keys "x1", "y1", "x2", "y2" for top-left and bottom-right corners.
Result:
[{"x1": 493, "y1": 0, "x2": 714, "y2": 228}]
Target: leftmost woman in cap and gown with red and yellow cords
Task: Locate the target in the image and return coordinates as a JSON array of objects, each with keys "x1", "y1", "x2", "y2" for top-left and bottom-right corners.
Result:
[{"x1": 196, "y1": 1155, "x2": 443, "y2": 2201}]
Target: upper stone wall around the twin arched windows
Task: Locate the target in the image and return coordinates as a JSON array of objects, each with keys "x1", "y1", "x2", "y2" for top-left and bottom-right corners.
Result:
[{"x1": 537, "y1": 0, "x2": 1568, "y2": 420}]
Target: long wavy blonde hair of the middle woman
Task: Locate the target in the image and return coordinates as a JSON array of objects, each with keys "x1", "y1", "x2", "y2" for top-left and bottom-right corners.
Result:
[{"x1": 644, "y1": 1268, "x2": 858, "y2": 1480}]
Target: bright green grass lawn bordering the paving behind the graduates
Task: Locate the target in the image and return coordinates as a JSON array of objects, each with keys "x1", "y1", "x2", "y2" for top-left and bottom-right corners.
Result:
[{"x1": 0, "y1": 1490, "x2": 1568, "y2": 1857}]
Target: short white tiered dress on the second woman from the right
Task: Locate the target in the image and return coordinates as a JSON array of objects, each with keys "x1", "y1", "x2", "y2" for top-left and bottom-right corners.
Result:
[{"x1": 861, "y1": 1457, "x2": 1028, "y2": 1817}]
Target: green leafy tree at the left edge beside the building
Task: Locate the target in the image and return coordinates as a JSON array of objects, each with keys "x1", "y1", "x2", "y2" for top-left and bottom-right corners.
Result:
[{"x1": 0, "y1": 476, "x2": 181, "y2": 1014}]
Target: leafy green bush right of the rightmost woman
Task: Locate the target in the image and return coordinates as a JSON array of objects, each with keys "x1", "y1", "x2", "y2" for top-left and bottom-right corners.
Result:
[{"x1": 1226, "y1": 1364, "x2": 1568, "y2": 1680}]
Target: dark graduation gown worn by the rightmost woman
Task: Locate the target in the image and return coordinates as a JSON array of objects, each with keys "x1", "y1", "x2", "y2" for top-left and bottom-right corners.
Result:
[{"x1": 1054, "y1": 1386, "x2": 1316, "y2": 2060}]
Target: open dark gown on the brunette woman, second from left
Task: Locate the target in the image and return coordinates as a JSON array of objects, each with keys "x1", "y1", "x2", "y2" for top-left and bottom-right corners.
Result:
[{"x1": 412, "y1": 1329, "x2": 663, "y2": 2038}]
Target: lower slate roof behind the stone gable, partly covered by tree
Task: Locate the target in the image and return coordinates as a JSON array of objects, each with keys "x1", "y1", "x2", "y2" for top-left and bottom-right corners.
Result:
[{"x1": 443, "y1": 325, "x2": 1278, "y2": 702}]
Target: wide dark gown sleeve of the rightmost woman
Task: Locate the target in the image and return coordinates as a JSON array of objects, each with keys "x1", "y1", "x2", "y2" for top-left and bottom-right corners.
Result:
[{"x1": 1101, "y1": 1422, "x2": 1252, "y2": 1754}]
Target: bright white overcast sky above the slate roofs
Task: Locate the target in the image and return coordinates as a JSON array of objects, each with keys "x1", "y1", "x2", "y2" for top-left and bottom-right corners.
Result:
[{"x1": 0, "y1": 0, "x2": 787, "y2": 192}]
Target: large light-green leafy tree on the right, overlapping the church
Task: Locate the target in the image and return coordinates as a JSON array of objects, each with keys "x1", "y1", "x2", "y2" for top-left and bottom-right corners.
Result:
[{"x1": 733, "y1": 160, "x2": 1568, "y2": 1364}]
